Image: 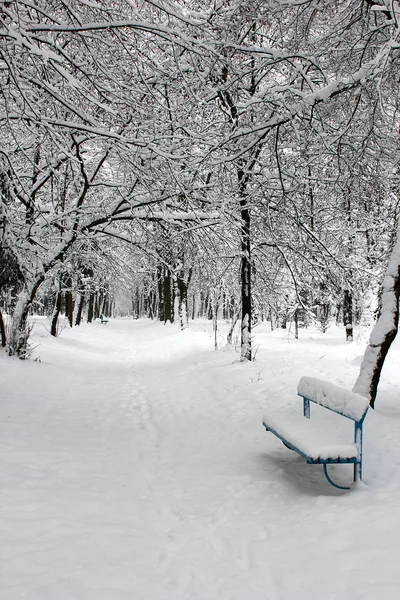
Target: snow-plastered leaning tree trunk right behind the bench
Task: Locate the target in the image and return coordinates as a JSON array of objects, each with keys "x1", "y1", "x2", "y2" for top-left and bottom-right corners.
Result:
[{"x1": 353, "y1": 228, "x2": 400, "y2": 407}]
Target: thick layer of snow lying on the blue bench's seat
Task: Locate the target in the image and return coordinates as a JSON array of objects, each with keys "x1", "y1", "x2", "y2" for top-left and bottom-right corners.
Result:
[{"x1": 263, "y1": 407, "x2": 359, "y2": 462}]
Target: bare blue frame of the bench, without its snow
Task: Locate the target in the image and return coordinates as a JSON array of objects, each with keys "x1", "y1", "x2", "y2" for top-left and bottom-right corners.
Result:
[{"x1": 263, "y1": 386, "x2": 368, "y2": 490}]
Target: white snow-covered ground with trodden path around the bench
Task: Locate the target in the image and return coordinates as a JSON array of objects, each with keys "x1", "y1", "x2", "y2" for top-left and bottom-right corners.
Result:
[{"x1": 0, "y1": 320, "x2": 400, "y2": 600}]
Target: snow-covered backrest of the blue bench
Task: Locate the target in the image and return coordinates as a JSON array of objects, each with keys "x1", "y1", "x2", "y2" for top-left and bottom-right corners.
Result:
[{"x1": 297, "y1": 377, "x2": 369, "y2": 422}]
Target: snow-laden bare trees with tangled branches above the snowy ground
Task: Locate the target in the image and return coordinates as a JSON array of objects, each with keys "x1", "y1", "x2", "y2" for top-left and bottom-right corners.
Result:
[{"x1": 0, "y1": 0, "x2": 400, "y2": 404}]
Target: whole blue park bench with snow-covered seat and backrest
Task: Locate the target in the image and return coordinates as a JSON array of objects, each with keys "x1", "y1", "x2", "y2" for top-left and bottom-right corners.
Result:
[{"x1": 263, "y1": 377, "x2": 369, "y2": 489}]
